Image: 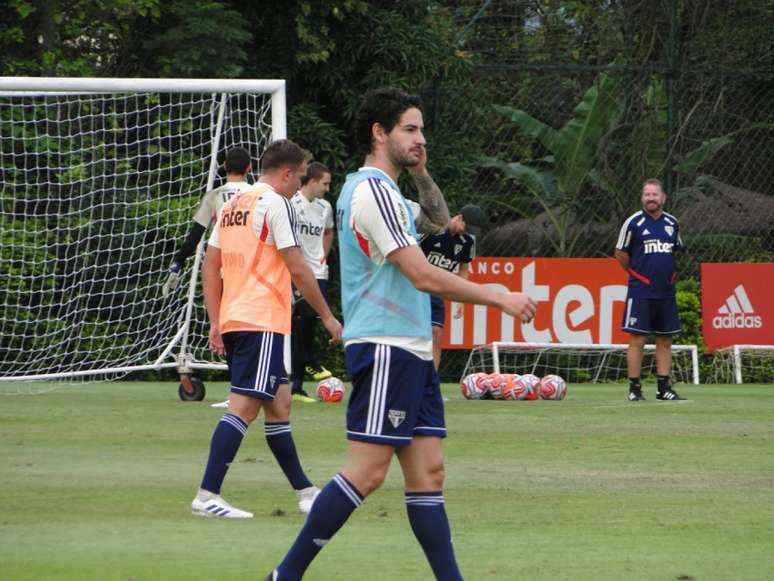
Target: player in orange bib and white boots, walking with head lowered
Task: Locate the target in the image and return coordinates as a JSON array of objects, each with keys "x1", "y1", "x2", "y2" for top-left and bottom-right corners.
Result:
[{"x1": 191, "y1": 139, "x2": 341, "y2": 518}]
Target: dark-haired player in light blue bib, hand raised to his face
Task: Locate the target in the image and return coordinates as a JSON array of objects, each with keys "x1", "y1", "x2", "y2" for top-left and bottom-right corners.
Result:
[{"x1": 266, "y1": 88, "x2": 536, "y2": 581}]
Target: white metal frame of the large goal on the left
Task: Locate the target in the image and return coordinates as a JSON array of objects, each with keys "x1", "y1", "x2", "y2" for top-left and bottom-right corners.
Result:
[{"x1": 0, "y1": 77, "x2": 287, "y2": 382}]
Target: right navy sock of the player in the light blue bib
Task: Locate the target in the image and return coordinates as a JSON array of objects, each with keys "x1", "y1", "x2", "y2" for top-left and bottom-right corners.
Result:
[{"x1": 406, "y1": 490, "x2": 462, "y2": 581}]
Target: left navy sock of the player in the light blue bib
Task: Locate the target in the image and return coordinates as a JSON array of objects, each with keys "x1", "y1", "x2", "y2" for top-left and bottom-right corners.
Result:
[{"x1": 277, "y1": 474, "x2": 363, "y2": 581}]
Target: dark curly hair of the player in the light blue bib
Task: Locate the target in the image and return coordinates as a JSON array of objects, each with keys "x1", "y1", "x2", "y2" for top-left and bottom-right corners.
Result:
[{"x1": 355, "y1": 87, "x2": 422, "y2": 155}]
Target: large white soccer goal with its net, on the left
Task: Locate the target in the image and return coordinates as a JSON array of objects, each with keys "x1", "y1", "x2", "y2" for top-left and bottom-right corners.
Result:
[{"x1": 0, "y1": 77, "x2": 286, "y2": 391}]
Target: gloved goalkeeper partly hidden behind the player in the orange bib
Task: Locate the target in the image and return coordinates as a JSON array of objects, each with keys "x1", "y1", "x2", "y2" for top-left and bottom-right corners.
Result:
[{"x1": 161, "y1": 147, "x2": 252, "y2": 297}]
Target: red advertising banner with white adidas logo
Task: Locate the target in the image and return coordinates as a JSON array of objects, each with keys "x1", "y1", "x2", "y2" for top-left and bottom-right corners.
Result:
[{"x1": 701, "y1": 262, "x2": 774, "y2": 351}]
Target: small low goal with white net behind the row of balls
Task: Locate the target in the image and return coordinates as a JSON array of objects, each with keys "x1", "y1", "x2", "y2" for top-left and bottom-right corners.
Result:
[{"x1": 462, "y1": 342, "x2": 699, "y2": 384}]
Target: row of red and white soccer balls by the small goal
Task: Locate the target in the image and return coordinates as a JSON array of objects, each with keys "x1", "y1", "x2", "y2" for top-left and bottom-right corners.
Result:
[{"x1": 460, "y1": 373, "x2": 567, "y2": 401}]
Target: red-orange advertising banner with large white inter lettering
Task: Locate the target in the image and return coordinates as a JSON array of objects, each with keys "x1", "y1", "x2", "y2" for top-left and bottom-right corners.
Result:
[{"x1": 443, "y1": 258, "x2": 628, "y2": 349}]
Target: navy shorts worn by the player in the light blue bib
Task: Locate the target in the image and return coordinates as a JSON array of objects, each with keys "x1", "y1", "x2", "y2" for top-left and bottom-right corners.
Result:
[{"x1": 345, "y1": 343, "x2": 446, "y2": 446}]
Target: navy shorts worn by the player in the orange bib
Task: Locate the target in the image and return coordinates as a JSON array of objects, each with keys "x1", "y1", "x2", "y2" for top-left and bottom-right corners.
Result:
[{"x1": 223, "y1": 331, "x2": 288, "y2": 400}]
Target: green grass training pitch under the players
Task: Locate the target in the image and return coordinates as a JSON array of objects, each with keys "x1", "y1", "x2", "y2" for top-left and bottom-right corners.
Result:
[{"x1": 0, "y1": 382, "x2": 774, "y2": 581}]
